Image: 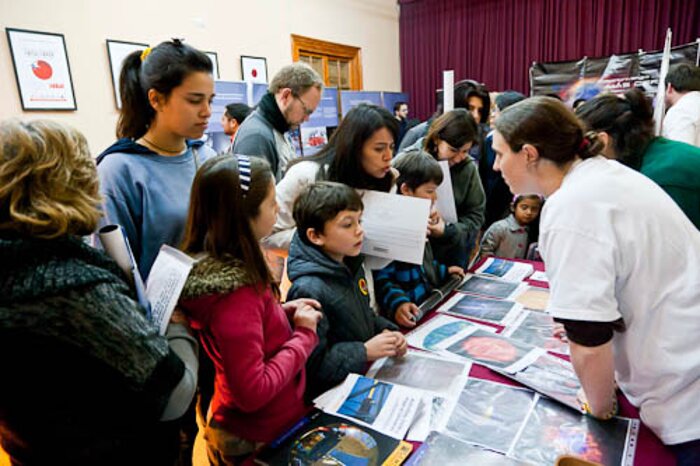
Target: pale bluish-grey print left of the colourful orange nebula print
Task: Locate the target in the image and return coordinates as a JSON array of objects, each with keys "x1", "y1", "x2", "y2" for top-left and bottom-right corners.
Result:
[{"x1": 444, "y1": 378, "x2": 536, "y2": 456}]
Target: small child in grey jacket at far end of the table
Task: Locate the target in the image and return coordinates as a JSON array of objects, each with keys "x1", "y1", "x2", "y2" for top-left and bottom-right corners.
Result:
[{"x1": 480, "y1": 194, "x2": 544, "y2": 259}]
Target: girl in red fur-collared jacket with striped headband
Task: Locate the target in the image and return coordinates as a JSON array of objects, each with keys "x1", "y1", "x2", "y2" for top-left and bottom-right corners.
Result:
[{"x1": 180, "y1": 155, "x2": 321, "y2": 465}]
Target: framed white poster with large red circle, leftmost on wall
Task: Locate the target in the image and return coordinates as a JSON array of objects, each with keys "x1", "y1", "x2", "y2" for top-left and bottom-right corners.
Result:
[{"x1": 5, "y1": 28, "x2": 78, "y2": 110}]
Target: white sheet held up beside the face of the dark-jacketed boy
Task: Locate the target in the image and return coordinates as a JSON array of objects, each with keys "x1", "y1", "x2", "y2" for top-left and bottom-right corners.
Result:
[{"x1": 362, "y1": 191, "x2": 430, "y2": 264}]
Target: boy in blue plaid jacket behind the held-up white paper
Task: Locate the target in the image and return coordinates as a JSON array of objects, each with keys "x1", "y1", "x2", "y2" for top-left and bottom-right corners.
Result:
[{"x1": 374, "y1": 149, "x2": 464, "y2": 327}]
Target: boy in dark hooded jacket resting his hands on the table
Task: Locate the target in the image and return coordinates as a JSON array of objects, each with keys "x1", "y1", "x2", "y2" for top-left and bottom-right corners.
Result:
[{"x1": 288, "y1": 182, "x2": 407, "y2": 398}]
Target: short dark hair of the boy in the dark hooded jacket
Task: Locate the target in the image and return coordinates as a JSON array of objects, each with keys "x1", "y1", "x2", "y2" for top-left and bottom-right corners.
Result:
[{"x1": 293, "y1": 181, "x2": 364, "y2": 246}]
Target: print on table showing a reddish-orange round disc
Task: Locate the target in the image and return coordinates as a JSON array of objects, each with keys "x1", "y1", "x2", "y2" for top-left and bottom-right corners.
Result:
[{"x1": 446, "y1": 329, "x2": 544, "y2": 372}]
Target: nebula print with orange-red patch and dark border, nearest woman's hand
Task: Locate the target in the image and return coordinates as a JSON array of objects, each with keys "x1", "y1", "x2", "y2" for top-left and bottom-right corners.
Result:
[{"x1": 511, "y1": 398, "x2": 639, "y2": 466}]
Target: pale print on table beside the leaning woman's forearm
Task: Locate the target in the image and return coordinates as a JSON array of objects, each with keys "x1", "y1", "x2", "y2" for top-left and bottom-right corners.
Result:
[{"x1": 506, "y1": 354, "x2": 581, "y2": 412}]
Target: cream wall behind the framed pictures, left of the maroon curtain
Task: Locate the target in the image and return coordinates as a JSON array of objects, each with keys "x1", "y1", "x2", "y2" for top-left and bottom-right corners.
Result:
[{"x1": 0, "y1": 0, "x2": 401, "y2": 154}]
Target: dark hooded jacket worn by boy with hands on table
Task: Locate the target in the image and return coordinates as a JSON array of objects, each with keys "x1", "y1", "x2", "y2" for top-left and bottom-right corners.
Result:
[{"x1": 287, "y1": 233, "x2": 398, "y2": 400}]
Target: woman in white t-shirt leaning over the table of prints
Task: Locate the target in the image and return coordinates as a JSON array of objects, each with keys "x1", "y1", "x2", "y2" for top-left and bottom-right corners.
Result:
[{"x1": 493, "y1": 97, "x2": 700, "y2": 465}]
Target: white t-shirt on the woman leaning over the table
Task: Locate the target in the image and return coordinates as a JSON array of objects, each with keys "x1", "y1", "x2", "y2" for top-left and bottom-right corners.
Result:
[{"x1": 539, "y1": 157, "x2": 700, "y2": 444}]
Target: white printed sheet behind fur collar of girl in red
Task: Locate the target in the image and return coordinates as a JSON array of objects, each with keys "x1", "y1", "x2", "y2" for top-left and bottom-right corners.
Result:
[{"x1": 146, "y1": 244, "x2": 195, "y2": 335}]
